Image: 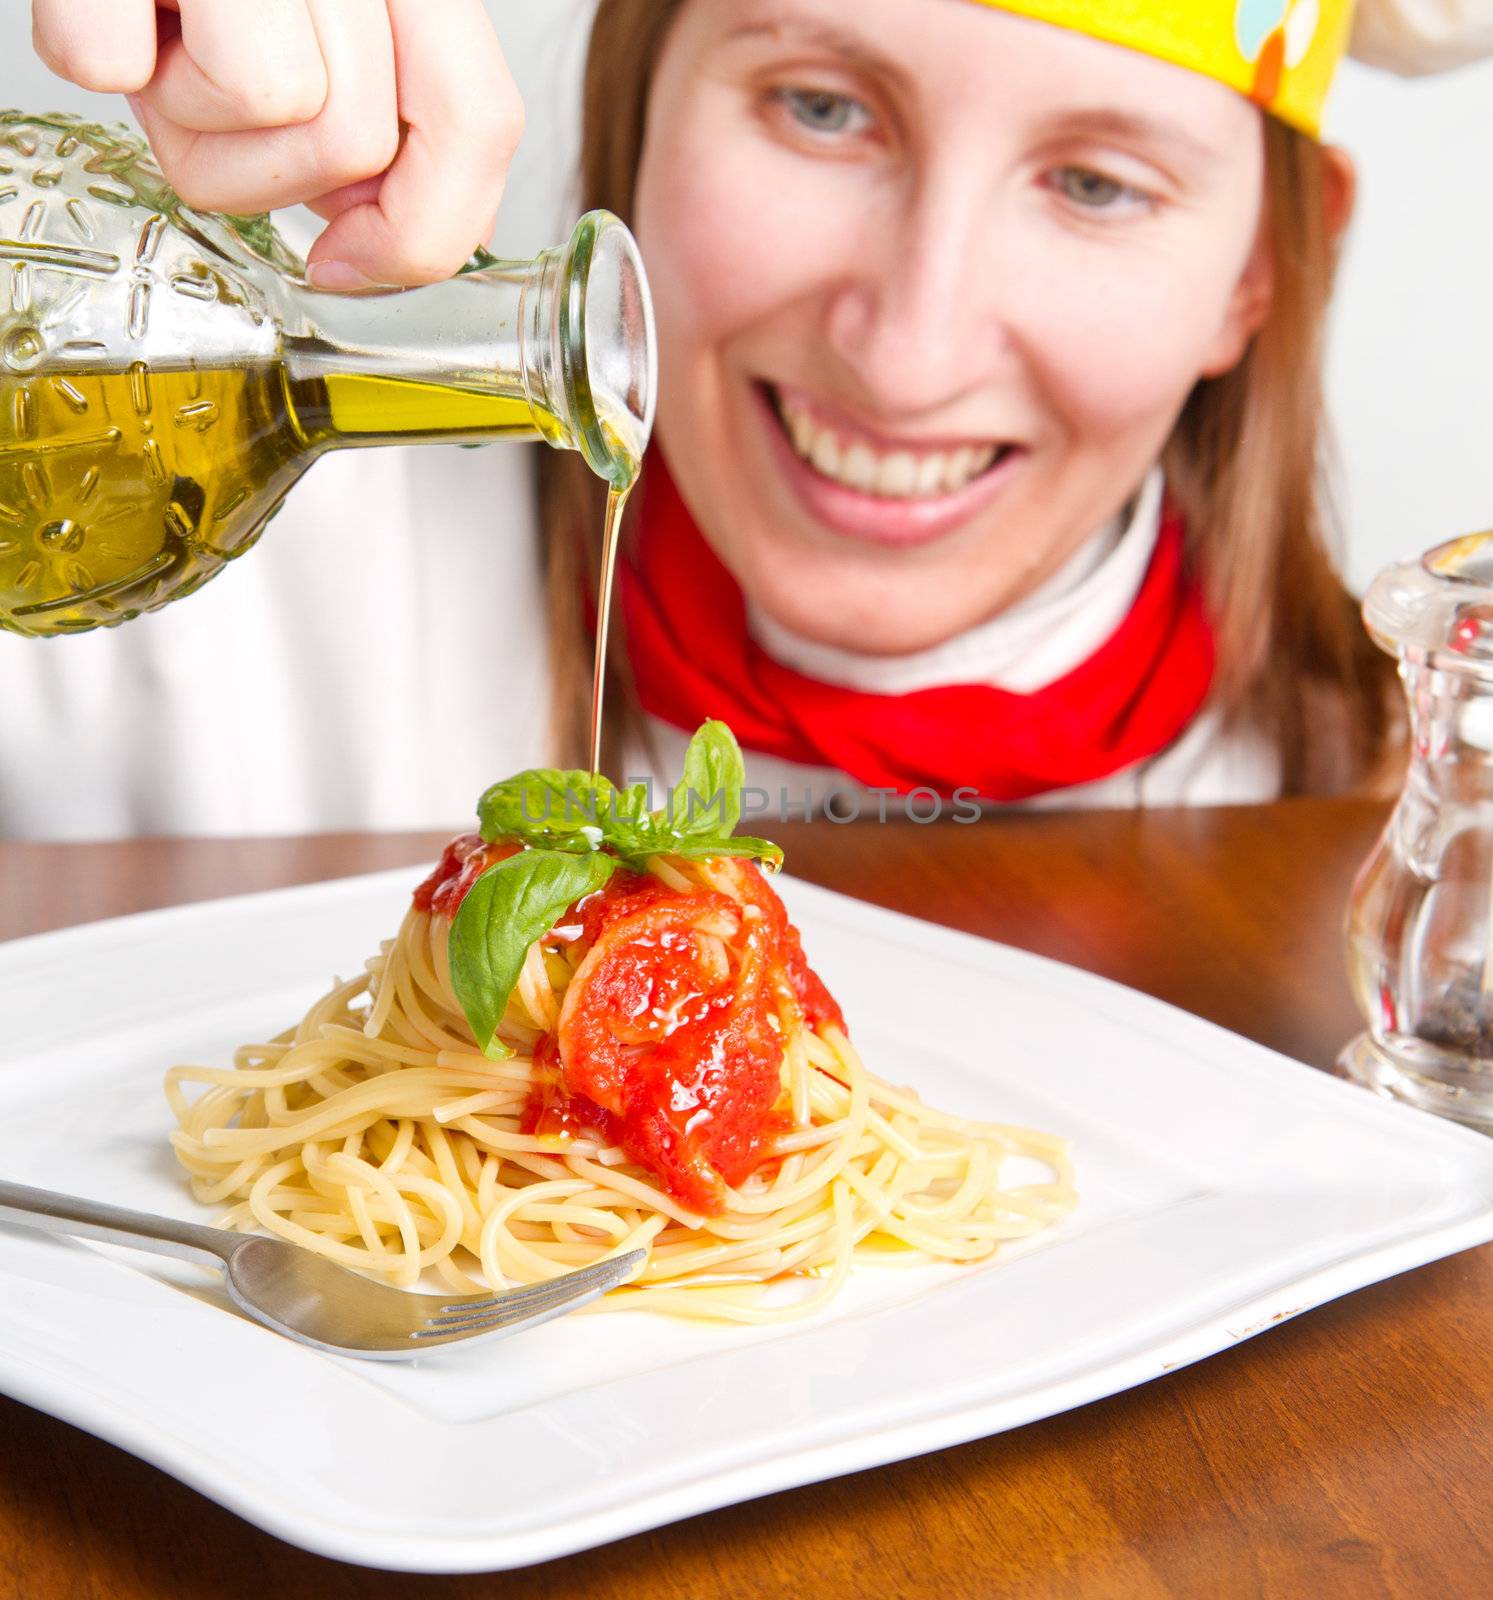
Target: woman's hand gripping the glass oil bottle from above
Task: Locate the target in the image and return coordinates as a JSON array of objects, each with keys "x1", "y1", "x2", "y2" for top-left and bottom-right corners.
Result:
[{"x1": 32, "y1": 0, "x2": 523, "y2": 290}]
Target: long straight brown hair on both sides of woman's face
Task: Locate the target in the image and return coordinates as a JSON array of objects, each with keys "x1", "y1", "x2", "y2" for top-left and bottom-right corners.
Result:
[{"x1": 539, "y1": 0, "x2": 1399, "y2": 794}]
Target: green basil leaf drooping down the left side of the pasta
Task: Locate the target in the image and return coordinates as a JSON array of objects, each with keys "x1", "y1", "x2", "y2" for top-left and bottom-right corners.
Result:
[{"x1": 448, "y1": 851, "x2": 616, "y2": 1061}]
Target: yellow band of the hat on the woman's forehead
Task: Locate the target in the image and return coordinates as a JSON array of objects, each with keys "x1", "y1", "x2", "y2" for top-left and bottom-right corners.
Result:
[{"x1": 960, "y1": 0, "x2": 1354, "y2": 138}]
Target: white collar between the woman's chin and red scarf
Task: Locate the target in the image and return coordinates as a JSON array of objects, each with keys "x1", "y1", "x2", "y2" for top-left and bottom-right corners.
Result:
[{"x1": 747, "y1": 467, "x2": 1163, "y2": 694}]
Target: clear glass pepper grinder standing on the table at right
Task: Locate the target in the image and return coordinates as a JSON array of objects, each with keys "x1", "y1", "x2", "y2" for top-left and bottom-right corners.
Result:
[{"x1": 1339, "y1": 533, "x2": 1493, "y2": 1130}]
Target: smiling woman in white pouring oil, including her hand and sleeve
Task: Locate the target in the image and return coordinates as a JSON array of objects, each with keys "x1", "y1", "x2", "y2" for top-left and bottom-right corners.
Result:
[{"x1": 11, "y1": 0, "x2": 1488, "y2": 837}]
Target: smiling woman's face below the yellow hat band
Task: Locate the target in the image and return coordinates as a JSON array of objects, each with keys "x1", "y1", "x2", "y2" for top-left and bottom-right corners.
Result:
[{"x1": 637, "y1": 0, "x2": 1269, "y2": 654}]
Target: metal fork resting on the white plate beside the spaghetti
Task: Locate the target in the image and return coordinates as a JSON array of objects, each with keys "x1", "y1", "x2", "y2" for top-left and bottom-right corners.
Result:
[{"x1": 0, "y1": 1181, "x2": 648, "y2": 1362}]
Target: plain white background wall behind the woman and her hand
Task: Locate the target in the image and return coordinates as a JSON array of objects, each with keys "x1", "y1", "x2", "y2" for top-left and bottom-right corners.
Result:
[{"x1": 0, "y1": 0, "x2": 1493, "y2": 589}]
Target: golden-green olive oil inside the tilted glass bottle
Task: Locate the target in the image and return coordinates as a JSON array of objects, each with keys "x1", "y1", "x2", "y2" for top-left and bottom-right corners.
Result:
[{"x1": 0, "y1": 362, "x2": 553, "y2": 635}]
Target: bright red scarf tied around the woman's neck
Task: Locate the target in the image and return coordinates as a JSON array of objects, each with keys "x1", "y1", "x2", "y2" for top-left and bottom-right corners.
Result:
[{"x1": 618, "y1": 456, "x2": 1213, "y2": 802}]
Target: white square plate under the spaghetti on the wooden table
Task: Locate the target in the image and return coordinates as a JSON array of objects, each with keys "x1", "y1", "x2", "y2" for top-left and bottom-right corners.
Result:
[{"x1": 0, "y1": 870, "x2": 1493, "y2": 1571}]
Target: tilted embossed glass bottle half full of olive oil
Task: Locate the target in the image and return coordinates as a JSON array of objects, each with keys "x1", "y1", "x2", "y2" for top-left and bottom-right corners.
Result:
[{"x1": 0, "y1": 112, "x2": 656, "y2": 635}]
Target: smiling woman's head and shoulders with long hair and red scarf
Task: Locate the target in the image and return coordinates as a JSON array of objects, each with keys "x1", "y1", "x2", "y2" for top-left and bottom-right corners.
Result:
[{"x1": 542, "y1": 0, "x2": 1391, "y2": 803}]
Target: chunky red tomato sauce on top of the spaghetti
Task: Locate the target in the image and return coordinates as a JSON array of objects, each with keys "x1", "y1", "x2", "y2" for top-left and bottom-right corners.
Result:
[{"x1": 414, "y1": 834, "x2": 843, "y2": 1214}]
